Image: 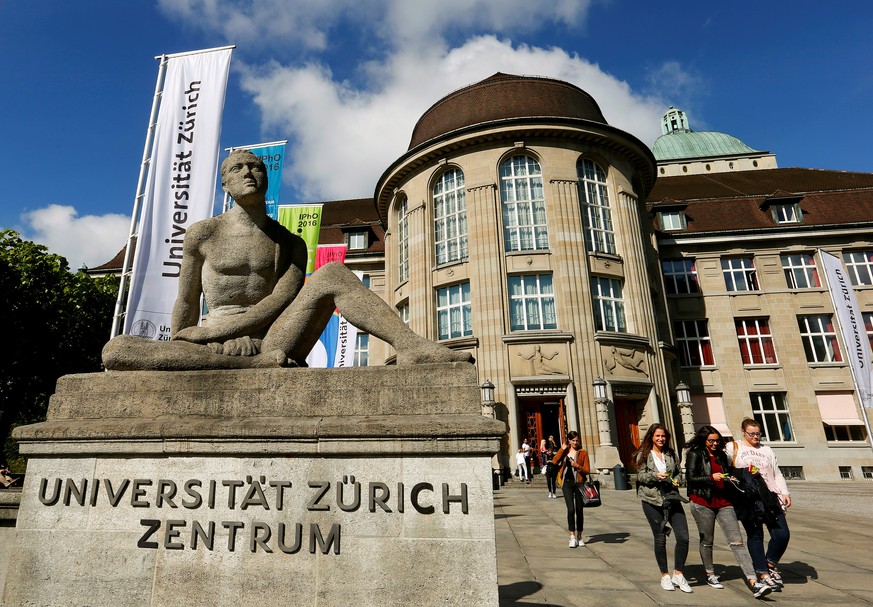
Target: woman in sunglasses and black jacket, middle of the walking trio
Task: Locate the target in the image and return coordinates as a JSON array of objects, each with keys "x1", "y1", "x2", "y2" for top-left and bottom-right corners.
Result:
[{"x1": 685, "y1": 426, "x2": 773, "y2": 598}]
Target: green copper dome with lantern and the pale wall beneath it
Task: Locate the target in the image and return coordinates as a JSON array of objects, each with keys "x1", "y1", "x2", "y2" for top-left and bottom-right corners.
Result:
[{"x1": 652, "y1": 106, "x2": 777, "y2": 177}]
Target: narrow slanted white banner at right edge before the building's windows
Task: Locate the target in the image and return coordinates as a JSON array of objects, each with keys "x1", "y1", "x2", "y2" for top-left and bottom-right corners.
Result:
[{"x1": 819, "y1": 250, "x2": 873, "y2": 409}]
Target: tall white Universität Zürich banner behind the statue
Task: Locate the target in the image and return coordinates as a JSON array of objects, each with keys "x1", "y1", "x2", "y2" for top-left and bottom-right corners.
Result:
[{"x1": 124, "y1": 48, "x2": 233, "y2": 340}]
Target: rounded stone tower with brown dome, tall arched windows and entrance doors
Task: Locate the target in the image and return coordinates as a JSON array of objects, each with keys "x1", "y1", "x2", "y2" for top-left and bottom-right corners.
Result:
[{"x1": 375, "y1": 73, "x2": 673, "y2": 478}]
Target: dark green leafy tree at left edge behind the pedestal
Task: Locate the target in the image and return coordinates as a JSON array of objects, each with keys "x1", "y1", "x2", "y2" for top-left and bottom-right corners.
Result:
[{"x1": 0, "y1": 230, "x2": 118, "y2": 469}]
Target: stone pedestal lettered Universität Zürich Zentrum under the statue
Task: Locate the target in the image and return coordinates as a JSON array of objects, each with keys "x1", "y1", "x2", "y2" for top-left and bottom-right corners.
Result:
[{"x1": 3, "y1": 363, "x2": 504, "y2": 607}]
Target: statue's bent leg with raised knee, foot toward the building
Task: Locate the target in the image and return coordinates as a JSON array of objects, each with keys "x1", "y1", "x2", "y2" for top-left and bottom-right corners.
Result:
[{"x1": 262, "y1": 263, "x2": 471, "y2": 364}]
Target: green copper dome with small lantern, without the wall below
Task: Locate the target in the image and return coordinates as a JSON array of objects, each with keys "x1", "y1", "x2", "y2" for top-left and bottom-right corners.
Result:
[{"x1": 652, "y1": 107, "x2": 765, "y2": 162}]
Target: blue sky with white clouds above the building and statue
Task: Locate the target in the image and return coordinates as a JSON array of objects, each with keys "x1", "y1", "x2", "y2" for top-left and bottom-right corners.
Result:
[{"x1": 0, "y1": 0, "x2": 873, "y2": 268}]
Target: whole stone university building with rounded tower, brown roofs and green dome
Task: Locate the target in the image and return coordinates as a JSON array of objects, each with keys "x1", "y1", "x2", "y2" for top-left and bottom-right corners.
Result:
[{"x1": 95, "y1": 73, "x2": 873, "y2": 482}]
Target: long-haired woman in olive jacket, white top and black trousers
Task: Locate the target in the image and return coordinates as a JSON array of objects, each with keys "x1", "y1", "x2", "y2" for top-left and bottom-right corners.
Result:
[{"x1": 634, "y1": 424, "x2": 693, "y2": 592}]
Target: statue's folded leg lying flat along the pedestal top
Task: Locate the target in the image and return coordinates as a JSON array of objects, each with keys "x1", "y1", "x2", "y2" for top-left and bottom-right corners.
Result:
[{"x1": 103, "y1": 335, "x2": 286, "y2": 371}]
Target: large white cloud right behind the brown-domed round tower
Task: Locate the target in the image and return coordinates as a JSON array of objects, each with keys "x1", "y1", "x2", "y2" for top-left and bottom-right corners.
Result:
[{"x1": 242, "y1": 36, "x2": 665, "y2": 200}]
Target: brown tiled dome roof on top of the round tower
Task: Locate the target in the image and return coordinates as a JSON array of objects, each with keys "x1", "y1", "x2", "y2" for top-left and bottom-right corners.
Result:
[{"x1": 409, "y1": 72, "x2": 608, "y2": 150}]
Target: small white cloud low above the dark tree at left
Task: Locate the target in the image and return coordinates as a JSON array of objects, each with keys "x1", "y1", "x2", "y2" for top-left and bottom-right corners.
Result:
[{"x1": 22, "y1": 204, "x2": 130, "y2": 270}]
